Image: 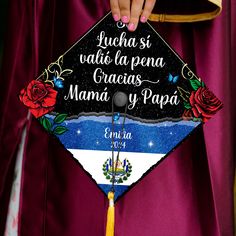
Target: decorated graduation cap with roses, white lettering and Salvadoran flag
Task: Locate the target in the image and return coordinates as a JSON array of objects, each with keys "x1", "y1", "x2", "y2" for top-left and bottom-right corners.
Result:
[{"x1": 20, "y1": 13, "x2": 222, "y2": 236}]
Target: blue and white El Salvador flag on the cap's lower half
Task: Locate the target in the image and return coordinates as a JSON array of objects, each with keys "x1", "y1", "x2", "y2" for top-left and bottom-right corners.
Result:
[{"x1": 46, "y1": 115, "x2": 201, "y2": 198}]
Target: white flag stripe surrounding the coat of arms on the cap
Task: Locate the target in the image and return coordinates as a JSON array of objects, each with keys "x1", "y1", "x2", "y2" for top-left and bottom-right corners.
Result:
[{"x1": 68, "y1": 149, "x2": 165, "y2": 185}]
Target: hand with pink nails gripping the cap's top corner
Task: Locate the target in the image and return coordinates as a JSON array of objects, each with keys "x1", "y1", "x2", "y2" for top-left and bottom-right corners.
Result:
[{"x1": 110, "y1": 0, "x2": 156, "y2": 31}]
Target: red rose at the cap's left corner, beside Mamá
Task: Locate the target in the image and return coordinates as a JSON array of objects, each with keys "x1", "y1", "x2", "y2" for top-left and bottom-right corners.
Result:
[{"x1": 19, "y1": 80, "x2": 57, "y2": 118}]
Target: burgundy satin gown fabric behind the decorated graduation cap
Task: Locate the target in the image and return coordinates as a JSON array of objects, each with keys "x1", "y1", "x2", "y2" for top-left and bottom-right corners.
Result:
[{"x1": 0, "y1": 0, "x2": 236, "y2": 236}]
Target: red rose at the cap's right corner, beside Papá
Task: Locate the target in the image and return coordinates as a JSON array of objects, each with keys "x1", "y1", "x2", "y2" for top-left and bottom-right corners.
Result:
[{"x1": 189, "y1": 87, "x2": 222, "y2": 122}]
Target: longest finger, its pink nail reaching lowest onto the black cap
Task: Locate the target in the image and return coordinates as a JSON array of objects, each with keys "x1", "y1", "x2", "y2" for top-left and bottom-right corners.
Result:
[{"x1": 128, "y1": 0, "x2": 144, "y2": 31}]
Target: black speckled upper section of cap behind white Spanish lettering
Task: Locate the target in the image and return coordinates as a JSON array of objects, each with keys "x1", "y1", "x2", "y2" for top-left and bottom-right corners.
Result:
[{"x1": 49, "y1": 11, "x2": 194, "y2": 121}]
